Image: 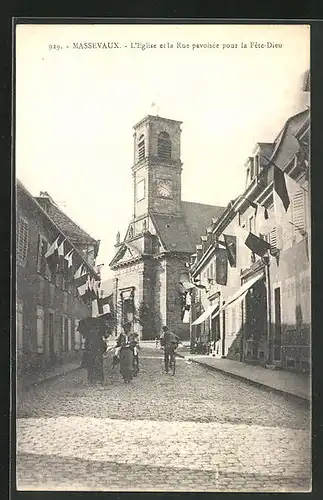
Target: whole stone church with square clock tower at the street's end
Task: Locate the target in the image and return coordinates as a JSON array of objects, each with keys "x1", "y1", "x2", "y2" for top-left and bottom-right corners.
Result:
[{"x1": 110, "y1": 115, "x2": 224, "y2": 339}]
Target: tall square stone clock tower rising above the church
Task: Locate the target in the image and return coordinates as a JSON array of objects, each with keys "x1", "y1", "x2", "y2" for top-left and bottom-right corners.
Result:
[{"x1": 132, "y1": 115, "x2": 182, "y2": 221}]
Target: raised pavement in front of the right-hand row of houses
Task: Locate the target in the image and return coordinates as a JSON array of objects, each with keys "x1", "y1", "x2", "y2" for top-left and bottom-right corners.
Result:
[{"x1": 185, "y1": 355, "x2": 311, "y2": 401}]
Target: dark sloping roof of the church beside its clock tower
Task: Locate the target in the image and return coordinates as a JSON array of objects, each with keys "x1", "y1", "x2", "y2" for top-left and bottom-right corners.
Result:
[{"x1": 151, "y1": 201, "x2": 224, "y2": 253}]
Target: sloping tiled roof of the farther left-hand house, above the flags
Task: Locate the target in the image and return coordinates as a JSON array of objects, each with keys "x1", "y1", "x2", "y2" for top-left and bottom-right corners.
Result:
[{"x1": 35, "y1": 197, "x2": 97, "y2": 244}]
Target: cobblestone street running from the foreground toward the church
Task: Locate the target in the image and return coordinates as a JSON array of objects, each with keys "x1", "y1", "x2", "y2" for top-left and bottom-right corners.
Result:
[{"x1": 17, "y1": 347, "x2": 311, "y2": 492}]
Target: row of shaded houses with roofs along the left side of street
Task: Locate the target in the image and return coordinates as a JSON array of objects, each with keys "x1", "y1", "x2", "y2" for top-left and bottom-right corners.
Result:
[{"x1": 16, "y1": 180, "x2": 99, "y2": 379}]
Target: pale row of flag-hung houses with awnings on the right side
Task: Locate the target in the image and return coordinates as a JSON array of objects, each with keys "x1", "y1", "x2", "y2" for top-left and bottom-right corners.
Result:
[{"x1": 191, "y1": 103, "x2": 311, "y2": 371}]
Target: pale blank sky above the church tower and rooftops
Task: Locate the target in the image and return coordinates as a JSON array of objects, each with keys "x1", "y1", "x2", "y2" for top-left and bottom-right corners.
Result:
[{"x1": 15, "y1": 24, "x2": 310, "y2": 279}]
